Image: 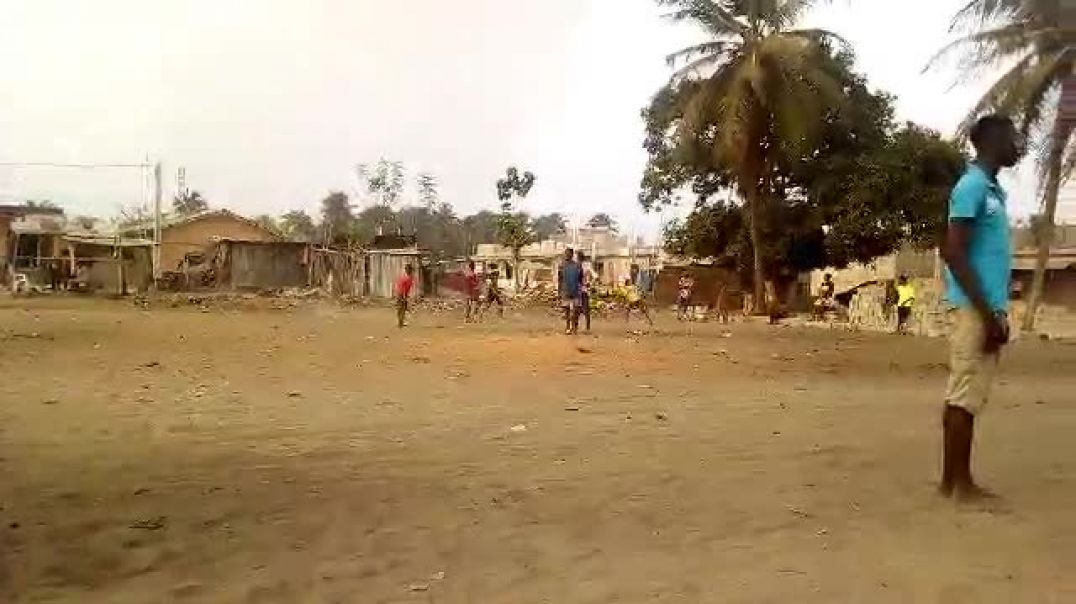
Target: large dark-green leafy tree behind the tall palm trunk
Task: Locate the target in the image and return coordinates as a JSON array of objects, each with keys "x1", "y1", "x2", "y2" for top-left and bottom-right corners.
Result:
[{"x1": 639, "y1": 40, "x2": 964, "y2": 291}]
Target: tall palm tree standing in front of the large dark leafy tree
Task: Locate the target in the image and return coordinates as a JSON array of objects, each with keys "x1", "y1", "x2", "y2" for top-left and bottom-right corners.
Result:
[{"x1": 659, "y1": 0, "x2": 844, "y2": 309}]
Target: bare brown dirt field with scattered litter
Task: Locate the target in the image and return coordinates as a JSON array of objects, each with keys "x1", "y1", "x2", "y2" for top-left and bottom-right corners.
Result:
[{"x1": 0, "y1": 299, "x2": 1076, "y2": 604}]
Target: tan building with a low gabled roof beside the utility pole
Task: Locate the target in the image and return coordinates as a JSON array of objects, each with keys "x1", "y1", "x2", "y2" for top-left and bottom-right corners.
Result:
[{"x1": 119, "y1": 210, "x2": 280, "y2": 271}]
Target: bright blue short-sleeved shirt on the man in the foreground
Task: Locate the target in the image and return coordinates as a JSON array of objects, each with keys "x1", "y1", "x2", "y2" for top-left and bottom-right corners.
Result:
[{"x1": 945, "y1": 164, "x2": 1013, "y2": 311}]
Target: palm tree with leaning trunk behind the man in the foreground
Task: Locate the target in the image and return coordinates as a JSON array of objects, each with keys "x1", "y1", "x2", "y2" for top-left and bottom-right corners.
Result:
[{"x1": 928, "y1": 0, "x2": 1076, "y2": 331}]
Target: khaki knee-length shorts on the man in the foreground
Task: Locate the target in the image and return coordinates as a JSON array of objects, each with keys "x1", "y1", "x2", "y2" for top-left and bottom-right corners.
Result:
[{"x1": 945, "y1": 308, "x2": 1000, "y2": 416}]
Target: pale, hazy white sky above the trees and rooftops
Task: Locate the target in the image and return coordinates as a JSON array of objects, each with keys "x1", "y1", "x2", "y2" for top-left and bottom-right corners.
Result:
[{"x1": 0, "y1": 0, "x2": 1036, "y2": 238}]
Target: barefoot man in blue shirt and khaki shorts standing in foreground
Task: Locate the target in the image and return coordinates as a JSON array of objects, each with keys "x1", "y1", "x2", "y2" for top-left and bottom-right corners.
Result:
[{"x1": 938, "y1": 115, "x2": 1022, "y2": 501}]
